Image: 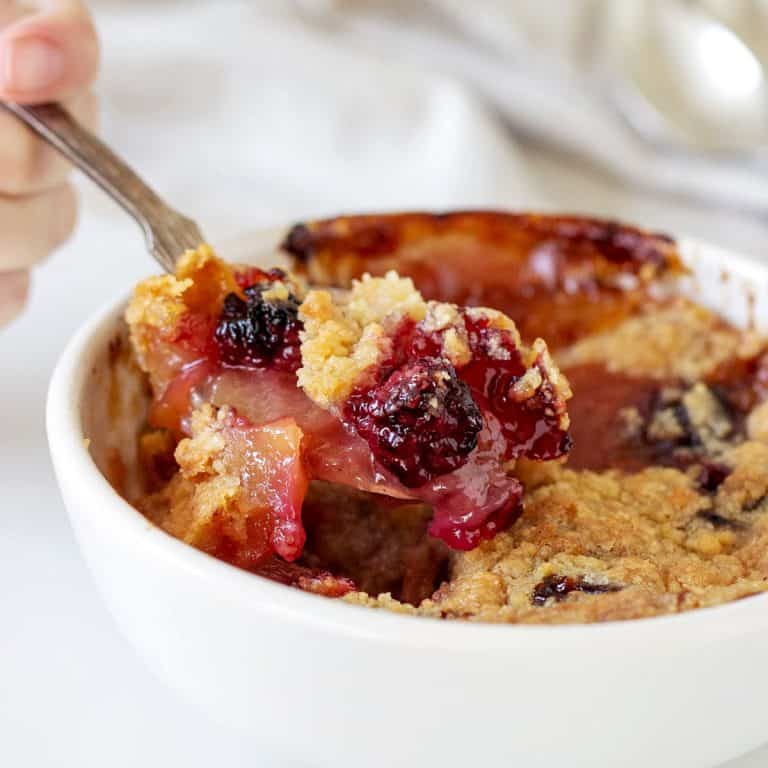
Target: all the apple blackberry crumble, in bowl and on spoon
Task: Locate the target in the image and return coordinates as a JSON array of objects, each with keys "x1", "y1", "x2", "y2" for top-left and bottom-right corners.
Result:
[{"x1": 126, "y1": 212, "x2": 768, "y2": 623}]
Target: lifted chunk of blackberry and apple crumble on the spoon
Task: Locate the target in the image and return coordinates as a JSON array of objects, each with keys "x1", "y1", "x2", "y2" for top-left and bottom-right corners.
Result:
[{"x1": 126, "y1": 247, "x2": 570, "y2": 572}]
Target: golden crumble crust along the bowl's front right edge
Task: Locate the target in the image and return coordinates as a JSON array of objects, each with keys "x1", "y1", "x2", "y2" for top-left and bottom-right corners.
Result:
[{"x1": 347, "y1": 442, "x2": 768, "y2": 623}]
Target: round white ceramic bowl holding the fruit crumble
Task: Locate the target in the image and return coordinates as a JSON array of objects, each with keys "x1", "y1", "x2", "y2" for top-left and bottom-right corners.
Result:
[{"x1": 47, "y1": 232, "x2": 768, "y2": 768}]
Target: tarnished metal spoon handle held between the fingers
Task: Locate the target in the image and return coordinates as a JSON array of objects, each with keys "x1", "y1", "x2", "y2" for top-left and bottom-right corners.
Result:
[{"x1": 0, "y1": 101, "x2": 204, "y2": 272}]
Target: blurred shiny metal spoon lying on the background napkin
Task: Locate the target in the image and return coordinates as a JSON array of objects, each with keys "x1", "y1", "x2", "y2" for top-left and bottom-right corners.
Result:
[{"x1": 601, "y1": 0, "x2": 768, "y2": 156}]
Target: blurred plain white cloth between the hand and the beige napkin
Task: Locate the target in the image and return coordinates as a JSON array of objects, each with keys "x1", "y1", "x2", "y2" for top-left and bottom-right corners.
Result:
[{"x1": 96, "y1": 2, "x2": 541, "y2": 238}]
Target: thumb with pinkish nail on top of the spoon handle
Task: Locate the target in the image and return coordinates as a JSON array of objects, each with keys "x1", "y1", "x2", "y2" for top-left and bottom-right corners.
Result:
[{"x1": 0, "y1": 0, "x2": 99, "y2": 103}]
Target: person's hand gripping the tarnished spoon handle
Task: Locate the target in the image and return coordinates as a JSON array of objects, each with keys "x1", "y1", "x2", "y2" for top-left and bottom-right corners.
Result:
[{"x1": 0, "y1": 0, "x2": 99, "y2": 326}]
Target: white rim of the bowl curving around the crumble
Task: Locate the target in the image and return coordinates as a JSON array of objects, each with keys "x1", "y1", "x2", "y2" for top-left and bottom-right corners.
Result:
[{"x1": 46, "y1": 232, "x2": 768, "y2": 652}]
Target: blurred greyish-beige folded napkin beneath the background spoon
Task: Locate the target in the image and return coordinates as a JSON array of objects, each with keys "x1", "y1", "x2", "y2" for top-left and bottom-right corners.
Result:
[{"x1": 292, "y1": 0, "x2": 768, "y2": 213}]
